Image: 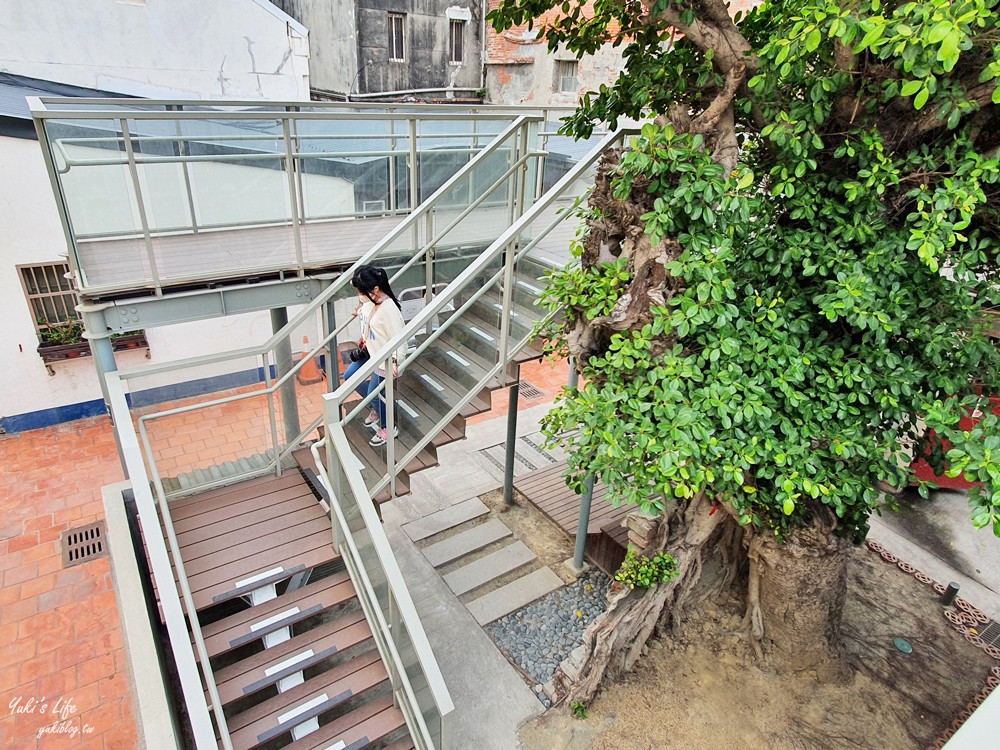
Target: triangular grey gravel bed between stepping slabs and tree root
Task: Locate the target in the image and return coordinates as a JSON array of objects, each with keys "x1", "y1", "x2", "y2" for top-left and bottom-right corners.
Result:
[{"x1": 484, "y1": 568, "x2": 611, "y2": 707}]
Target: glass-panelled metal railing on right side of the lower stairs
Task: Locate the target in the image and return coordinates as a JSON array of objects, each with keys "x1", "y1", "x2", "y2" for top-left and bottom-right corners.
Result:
[{"x1": 310, "y1": 432, "x2": 454, "y2": 750}]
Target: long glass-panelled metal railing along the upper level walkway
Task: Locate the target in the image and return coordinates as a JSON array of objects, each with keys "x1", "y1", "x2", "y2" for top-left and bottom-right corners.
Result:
[{"x1": 30, "y1": 97, "x2": 604, "y2": 295}]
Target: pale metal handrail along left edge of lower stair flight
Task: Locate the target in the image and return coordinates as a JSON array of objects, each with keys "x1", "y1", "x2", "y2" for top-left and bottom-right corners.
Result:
[{"x1": 105, "y1": 372, "x2": 233, "y2": 750}]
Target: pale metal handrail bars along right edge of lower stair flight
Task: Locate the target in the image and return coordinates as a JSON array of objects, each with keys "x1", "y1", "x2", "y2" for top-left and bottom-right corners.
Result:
[{"x1": 309, "y1": 434, "x2": 455, "y2": 750}]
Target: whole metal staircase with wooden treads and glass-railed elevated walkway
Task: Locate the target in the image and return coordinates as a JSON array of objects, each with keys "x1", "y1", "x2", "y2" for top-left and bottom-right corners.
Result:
[{"x1": 39, "y1": 95, "x2": 624, "y2": 750}]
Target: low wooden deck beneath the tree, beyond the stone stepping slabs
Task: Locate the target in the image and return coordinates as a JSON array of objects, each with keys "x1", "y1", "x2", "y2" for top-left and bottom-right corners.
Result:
[{"x1": 514, "y1": 462, "x2": 631, "y2": 575}]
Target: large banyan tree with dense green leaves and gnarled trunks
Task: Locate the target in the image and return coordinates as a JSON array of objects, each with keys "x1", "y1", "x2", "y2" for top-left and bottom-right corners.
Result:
[{"x1": 491, "y1": 0, "x2": 1000, "y2": 701}]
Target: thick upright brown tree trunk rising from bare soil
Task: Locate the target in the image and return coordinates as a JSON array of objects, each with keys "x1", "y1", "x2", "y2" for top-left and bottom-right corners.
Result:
[{"x1": 746, "y1": 523, "x2": 850, "y2": 681}]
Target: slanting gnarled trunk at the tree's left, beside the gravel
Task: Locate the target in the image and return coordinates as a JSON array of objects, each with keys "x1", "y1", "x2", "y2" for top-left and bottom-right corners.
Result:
[{"x1": 553, "y1": 495, "x2": 735, "y2": 704}]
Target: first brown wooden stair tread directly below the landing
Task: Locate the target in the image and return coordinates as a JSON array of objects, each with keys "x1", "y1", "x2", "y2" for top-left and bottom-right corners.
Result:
[{"x1": 202, "y1": 571, "x2": 355, "y2": 656}]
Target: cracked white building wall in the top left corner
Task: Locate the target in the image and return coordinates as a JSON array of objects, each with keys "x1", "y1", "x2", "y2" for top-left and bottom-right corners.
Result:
[{"x1": 0, "y1": 0, "x2": 309, "y2": 100}]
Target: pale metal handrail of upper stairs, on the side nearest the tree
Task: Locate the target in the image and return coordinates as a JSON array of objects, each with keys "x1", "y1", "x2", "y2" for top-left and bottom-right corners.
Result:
[{"x1": 323, "y1": 126, "x2": 635, "y2": 495}]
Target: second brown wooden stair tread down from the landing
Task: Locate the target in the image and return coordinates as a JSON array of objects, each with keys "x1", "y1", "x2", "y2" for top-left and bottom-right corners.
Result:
[{"x1": 215, "y1": 609, "x2": 372, "y2": 705}]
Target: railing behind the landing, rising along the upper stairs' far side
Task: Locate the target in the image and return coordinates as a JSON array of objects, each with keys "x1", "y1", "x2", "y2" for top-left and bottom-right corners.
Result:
[{"x1": 113, "y1": 117, "x2": 537, "y2": 506}]
